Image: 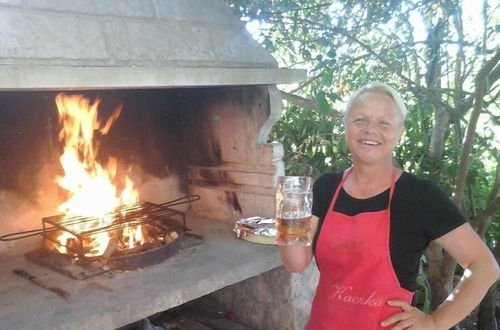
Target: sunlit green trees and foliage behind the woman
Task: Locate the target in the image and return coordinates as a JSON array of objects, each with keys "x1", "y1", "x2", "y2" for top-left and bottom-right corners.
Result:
[{"x1": 226, "y1": 0, "x2": 500, "y2": 324}]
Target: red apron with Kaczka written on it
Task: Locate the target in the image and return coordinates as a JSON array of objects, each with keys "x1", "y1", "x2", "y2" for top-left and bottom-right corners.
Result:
[{"x1": 307, "y1": 171, "x2": 413, "y2": 330}]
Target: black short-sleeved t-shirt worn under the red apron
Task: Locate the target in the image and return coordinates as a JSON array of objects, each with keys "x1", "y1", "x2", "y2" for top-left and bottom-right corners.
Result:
[{"x1": 312, "y1": 171, "x2": 465, "y2": 291}]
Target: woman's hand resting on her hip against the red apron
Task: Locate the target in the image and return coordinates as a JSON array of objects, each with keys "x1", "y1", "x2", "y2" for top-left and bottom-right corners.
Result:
[{"x1": 381, "y1": 300, "x2": 437, "y2": 330}]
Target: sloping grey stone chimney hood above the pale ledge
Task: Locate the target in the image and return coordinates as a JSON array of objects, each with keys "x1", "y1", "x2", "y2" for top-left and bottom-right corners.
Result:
[{"x1": 0, "y1": 0, "x2": 277, "y2": 67}]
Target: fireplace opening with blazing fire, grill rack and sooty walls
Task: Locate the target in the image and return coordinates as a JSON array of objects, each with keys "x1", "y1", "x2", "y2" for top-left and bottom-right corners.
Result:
[{"x1": 0, "y1": 86, "x2": 275, "y2": 270}]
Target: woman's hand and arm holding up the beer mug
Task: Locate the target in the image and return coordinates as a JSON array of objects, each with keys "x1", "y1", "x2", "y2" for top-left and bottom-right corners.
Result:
[{"x1": 279, "y1": 216, "x2": 319, "y2": 273}]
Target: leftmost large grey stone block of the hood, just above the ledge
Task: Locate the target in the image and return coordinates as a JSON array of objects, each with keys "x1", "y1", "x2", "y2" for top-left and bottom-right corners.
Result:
[{"x1": 0, "y1": 12, "x2": 108, "y2": 59}]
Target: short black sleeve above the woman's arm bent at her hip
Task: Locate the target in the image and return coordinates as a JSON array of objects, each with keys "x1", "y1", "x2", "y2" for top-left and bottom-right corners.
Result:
[{"x1": 421, "y1": 180, "x2": 466, "y2": 240}]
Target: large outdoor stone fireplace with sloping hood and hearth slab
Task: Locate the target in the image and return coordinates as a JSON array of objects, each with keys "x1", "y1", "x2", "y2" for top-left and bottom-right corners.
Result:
[{"x1": 0, "y1": 0, "x2": 313, "y2": 329}]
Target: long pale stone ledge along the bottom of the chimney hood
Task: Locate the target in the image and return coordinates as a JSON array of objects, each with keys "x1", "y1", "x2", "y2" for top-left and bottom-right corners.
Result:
[{"x1": 0, "y1": 65, "x2": 306, "y2": 90}]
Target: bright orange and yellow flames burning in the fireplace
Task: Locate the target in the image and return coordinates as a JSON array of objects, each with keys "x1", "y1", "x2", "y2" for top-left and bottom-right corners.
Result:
[{"x1": 56, "y1": 93, "x2": 143, "y2": 256}]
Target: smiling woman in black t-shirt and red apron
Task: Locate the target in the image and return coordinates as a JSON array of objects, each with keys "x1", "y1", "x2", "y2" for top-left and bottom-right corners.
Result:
[{"x1": 280, "y1": 83, "x2": 500, "y2": 330}]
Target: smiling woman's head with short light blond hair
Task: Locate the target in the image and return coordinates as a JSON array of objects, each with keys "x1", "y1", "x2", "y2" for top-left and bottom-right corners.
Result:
[{"x1": 344, "y1": 92, "x2": 403, "y2": 164}]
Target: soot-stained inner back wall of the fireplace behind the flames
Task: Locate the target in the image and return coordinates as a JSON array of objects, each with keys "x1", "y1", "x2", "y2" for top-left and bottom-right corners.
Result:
[{"x1": 0, "y1": 86, "x2": 275, "y2": 252}]
